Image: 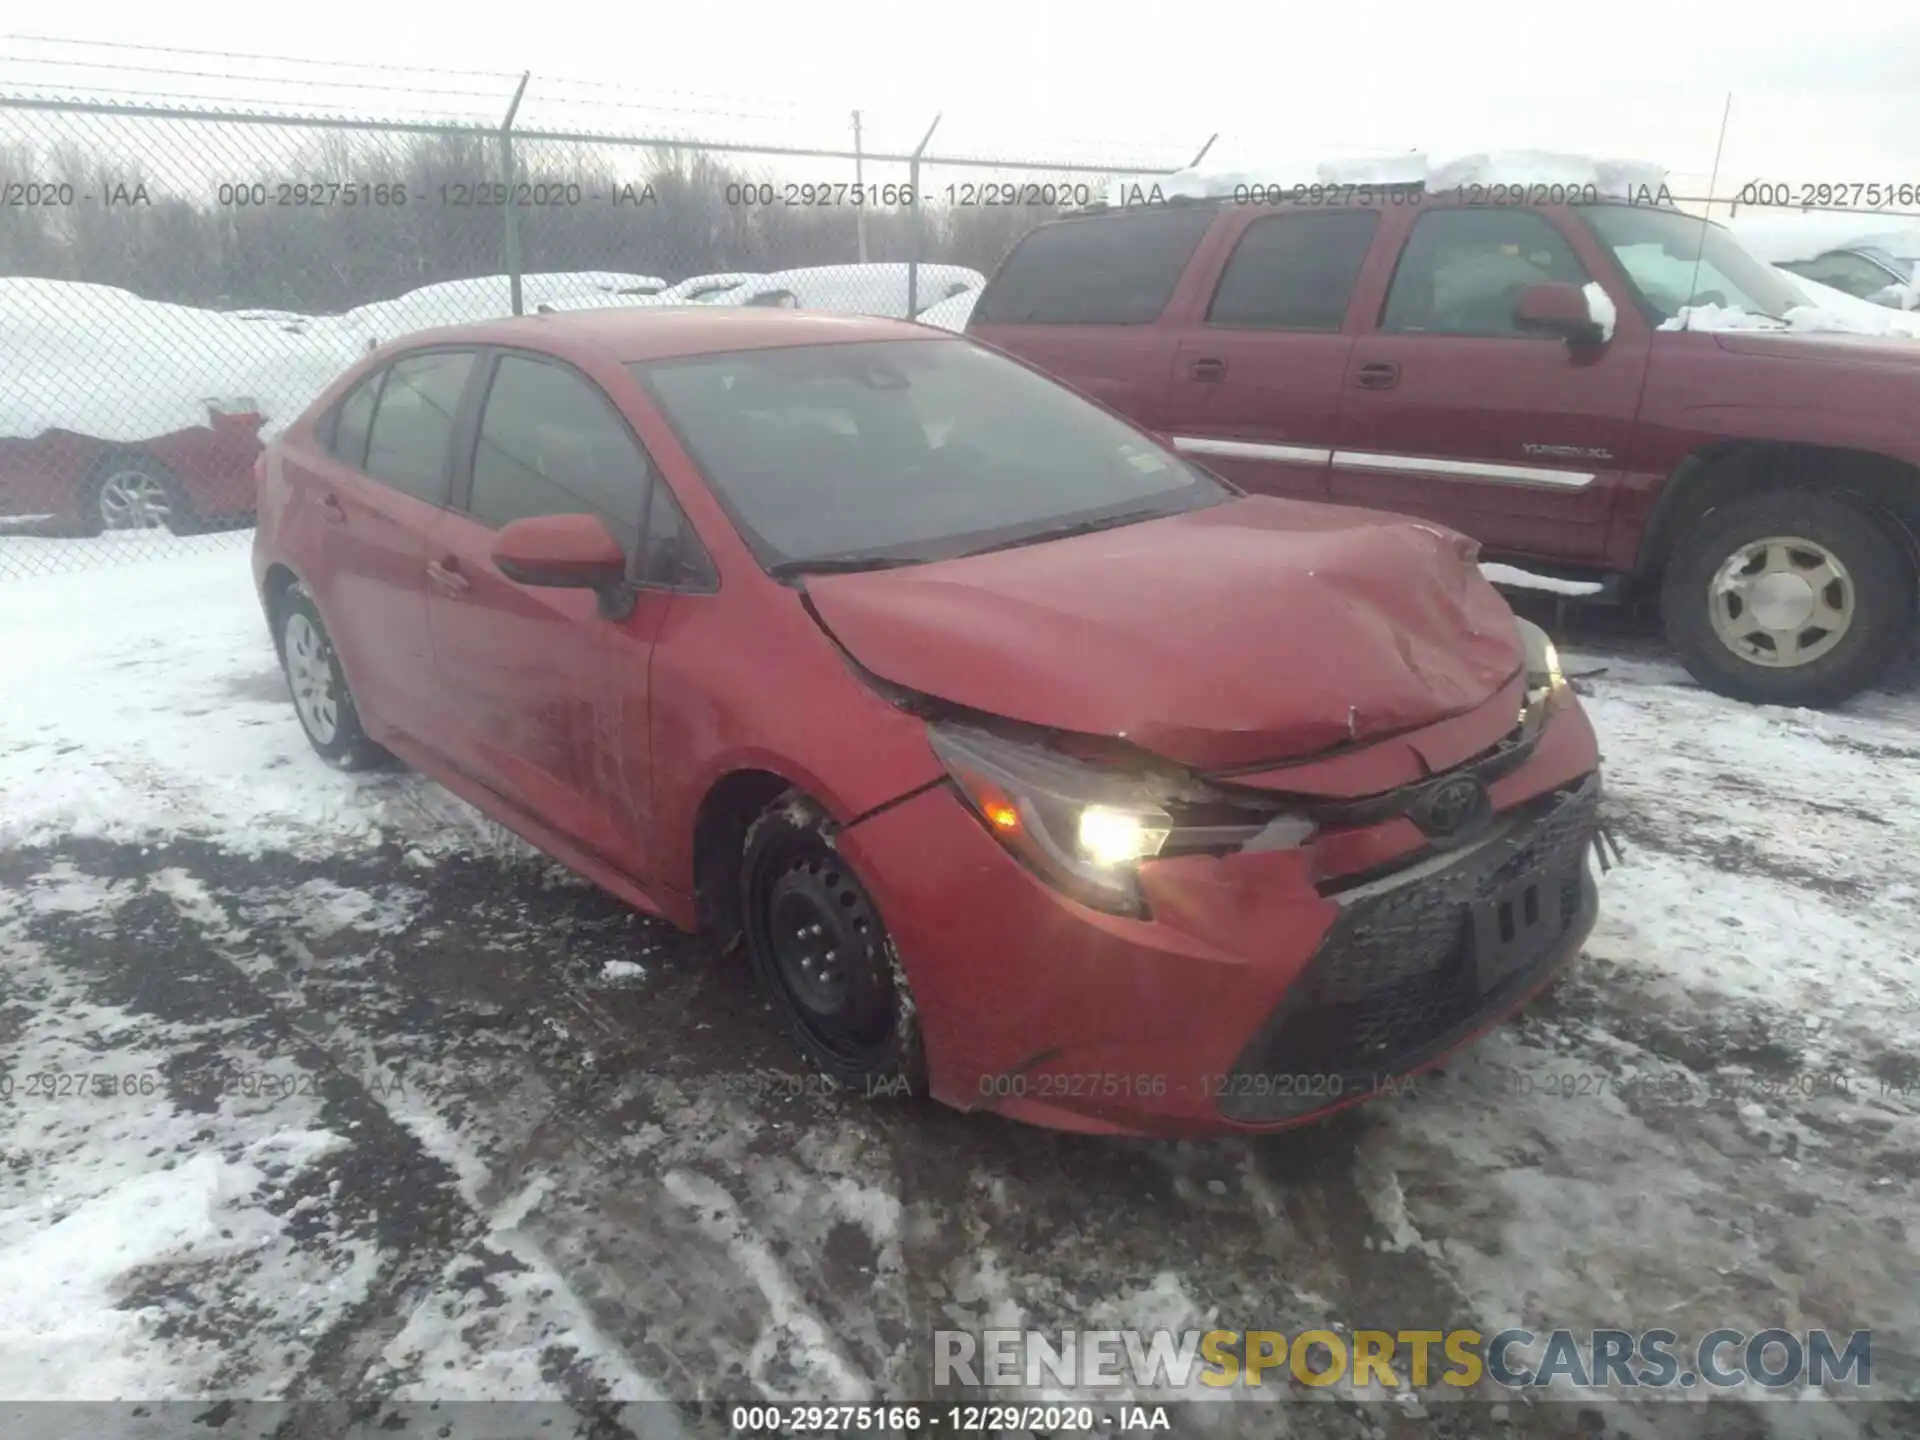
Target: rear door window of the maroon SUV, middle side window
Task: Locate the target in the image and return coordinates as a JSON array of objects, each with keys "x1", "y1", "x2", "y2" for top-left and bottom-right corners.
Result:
[{"x1": 1206, "y1": 209, "x2": 1380, "y2": 330}]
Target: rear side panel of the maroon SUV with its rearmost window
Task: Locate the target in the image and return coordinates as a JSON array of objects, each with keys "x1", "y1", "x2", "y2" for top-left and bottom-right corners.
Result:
[{"x1": 968, "y1": 205, "x2": 1217, "y2": 430}]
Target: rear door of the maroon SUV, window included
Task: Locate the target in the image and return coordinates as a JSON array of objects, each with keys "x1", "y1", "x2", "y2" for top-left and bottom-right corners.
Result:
[{"x1": 1165, "y1": 209, "x2": 1380, "y2": 499}]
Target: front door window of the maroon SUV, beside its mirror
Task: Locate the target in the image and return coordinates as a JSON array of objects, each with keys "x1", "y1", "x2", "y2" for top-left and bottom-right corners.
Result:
[{"x1": 1380, "y1": 207, "x2": 1588, "y2": 338}]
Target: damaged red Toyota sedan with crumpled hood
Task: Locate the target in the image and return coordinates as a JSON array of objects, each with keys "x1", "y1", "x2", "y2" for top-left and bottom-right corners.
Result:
[{"x1": 255, "y1": 309, "x2": 1599, "y2": 1135}]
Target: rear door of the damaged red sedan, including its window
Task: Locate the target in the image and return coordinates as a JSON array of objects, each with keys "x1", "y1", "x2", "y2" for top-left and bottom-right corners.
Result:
[{"x1": 305, "y1": 349, "x2": 474, "y2": 741}]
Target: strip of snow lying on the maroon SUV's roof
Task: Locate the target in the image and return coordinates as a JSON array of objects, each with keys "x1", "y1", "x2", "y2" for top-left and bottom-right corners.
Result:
[{"x1": 1108, "y1": 150, "x2": 1668, "y2": 204}]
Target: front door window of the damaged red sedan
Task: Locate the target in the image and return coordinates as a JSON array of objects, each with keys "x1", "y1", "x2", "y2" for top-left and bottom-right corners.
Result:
[{"x1": 467, "y1": 355, "x2": 649, "y2": 551}]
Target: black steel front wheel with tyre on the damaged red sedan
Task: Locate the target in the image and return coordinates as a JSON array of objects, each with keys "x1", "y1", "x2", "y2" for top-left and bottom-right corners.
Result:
[{"x1": 741, "y1": 791, "x2": 925, "y2": 1094}]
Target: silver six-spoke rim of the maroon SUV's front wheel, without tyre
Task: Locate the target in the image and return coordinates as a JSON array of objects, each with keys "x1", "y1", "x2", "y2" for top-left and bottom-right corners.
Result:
[{"x1": 1707, "y1": 536, "x2": 1855, "y2": 666}]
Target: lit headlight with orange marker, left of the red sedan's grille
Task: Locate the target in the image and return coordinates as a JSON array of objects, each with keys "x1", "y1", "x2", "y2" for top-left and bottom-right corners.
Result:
[{"x1": 927, "y1": 722, "x2": 1313, "y2": 914}]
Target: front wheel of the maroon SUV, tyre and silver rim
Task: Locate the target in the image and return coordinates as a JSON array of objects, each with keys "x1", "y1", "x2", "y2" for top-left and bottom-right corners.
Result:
[{"x1": 1661, "y1": 490, "x2": 1914, "y2": 707}]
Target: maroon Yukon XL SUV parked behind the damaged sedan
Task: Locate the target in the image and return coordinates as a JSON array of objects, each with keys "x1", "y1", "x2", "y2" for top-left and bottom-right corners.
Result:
[{"x1": 968, "y1": 186, "x2": 1920, "y2": 705}]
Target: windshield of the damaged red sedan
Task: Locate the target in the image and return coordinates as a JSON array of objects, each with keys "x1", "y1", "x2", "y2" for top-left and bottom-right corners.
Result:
[{"x1": 630, "y1": 340, "x2": 1235, "y2": 570}]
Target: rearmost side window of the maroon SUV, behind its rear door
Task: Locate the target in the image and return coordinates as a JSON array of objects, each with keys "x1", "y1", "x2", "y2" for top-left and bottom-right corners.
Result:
[{"x1": 973, "y1": 205, "x2": 1215, "y2": 324}]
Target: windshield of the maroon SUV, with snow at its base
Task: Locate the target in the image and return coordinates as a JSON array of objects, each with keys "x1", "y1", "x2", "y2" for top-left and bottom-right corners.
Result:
[{"x1": 1578, "y1": 205, "x2": 1807, "y2": 323}]
